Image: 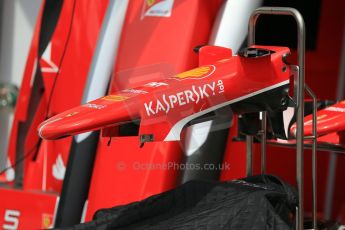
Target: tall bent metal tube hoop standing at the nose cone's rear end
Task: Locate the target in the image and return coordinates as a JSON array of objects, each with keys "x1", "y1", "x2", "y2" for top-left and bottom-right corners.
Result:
[{"x1": 246, "y1": 7, "x2": 308, "y2": 229}]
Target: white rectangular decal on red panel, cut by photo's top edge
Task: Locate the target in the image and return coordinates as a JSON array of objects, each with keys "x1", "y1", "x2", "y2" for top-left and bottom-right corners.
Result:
[{"x1": 141, "y1": 0, "x2": 174, "y2": 20}]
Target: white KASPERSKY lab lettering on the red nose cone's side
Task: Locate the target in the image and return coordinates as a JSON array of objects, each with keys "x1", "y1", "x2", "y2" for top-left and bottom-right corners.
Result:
[{"x1": 144, "y1": 80, "x2": 224, "y2": 116}]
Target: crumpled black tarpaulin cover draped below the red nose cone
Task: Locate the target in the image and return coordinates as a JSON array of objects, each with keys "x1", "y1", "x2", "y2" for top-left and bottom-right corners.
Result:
[{"x1": 56, "y1": 175, "x2": 297, "y2": 230}]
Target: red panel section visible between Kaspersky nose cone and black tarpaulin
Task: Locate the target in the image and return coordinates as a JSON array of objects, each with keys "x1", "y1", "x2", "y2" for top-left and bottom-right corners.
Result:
[{"x1": 85, "y1": 136, "x2": 183, "y2": 221}]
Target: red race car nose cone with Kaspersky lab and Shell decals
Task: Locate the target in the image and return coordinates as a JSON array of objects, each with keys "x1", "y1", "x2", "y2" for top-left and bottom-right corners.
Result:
[{"x1": 38, "y1": 46, "x2": 289, "y2": 141}]
